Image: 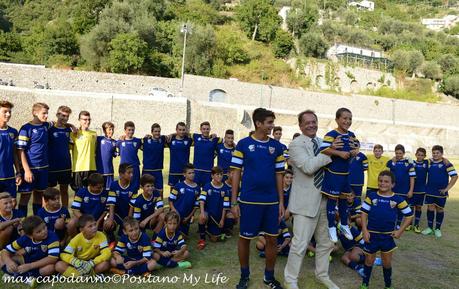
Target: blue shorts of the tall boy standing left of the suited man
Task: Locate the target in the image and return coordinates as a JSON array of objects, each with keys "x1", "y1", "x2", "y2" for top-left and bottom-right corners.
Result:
[{"x1": 239, "y1": 203, "x2": 279, "y2": 239}]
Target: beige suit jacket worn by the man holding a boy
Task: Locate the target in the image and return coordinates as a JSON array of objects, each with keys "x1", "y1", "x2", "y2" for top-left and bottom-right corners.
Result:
[{"x1": 288, "y1": 134, "x2": 331, "y2": 218}]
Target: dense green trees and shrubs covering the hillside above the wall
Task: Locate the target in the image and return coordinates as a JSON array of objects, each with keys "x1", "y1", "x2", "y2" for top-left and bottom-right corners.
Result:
[{"x1": 0, "y1": 0, "x2": 459, "y2": 97}]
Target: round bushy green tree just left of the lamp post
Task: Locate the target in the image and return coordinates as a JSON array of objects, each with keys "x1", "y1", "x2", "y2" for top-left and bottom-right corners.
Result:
[{"x1": 108, "y1": 33, "x2": 148, "y2": 73}]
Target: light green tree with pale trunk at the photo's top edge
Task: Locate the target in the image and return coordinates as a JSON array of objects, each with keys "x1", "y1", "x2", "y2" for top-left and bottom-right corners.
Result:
[{"x1": 236, "y1": 0, "x2": 281, "y2": 42}]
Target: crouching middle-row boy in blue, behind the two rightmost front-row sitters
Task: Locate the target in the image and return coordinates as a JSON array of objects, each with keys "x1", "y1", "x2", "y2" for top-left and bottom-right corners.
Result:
[{"x1": 129, "y1": 174, "x2": 164, "y2": 236}]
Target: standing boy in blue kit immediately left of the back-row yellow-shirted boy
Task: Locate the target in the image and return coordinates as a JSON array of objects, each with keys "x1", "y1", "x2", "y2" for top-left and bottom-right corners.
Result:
[{"x1": 48, "y1": 105, "x2": 72, "y2": 207}]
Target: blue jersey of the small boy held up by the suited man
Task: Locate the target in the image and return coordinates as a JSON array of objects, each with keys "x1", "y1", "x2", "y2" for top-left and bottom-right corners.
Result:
[{"x1": 320, "y1": 130, "x2": 355, "y2": 175}]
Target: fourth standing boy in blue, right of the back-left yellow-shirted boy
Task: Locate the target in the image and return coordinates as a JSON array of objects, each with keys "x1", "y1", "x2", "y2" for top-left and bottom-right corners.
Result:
[{"x1": 168, "y1": 122, "x2": 193, "y2": 190}]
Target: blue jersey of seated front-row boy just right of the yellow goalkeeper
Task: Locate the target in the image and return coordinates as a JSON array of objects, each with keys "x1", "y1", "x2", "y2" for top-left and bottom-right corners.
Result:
[{"x1": 115, "y1": 232, "x2": 153, "y2": 260}]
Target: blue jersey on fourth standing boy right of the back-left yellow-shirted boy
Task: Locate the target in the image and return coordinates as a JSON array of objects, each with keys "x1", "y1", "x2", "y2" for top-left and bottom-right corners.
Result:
[{"x1": 169, "y1": 136, "x2": 193, "y2": 175}]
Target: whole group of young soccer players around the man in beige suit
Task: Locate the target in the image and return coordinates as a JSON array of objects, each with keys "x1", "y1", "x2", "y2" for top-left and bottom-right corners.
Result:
[{"x1": 0, "y1": 101, "x2": 457, "y2": 288}]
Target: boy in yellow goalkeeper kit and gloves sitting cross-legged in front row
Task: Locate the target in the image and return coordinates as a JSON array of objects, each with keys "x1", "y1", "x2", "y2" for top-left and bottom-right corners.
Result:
[{"x1": 56, "y1": 215, "x2": 112, "y2": 277}]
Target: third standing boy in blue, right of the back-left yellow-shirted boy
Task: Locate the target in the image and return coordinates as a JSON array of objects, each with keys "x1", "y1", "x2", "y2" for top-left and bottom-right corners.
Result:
[{"x1": 142, "y1": 123, "x2": 167, "y2": 197}]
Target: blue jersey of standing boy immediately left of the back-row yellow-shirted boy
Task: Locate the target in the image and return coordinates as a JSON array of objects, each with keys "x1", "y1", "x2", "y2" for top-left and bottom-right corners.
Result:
[{"x1": 48, "y1": 126, "x2": 72, "y2": 172}]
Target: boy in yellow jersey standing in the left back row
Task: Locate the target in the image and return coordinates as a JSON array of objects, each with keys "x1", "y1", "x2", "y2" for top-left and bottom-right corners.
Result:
[{"x1": 71, "y1": 110, "x2": 97, "y2": 192}]
